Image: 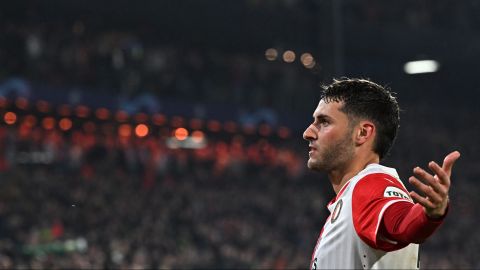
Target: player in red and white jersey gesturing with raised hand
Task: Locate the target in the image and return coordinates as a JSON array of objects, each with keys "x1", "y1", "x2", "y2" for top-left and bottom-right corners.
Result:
[{"x1": 303, "y1": 79, "x2": 460, "y2": 269}]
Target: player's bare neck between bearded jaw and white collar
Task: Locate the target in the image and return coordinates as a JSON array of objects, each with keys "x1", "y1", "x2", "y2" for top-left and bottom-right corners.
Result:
[{"x1": 328, "y1": 156, "x2": 380, "y2": 194}]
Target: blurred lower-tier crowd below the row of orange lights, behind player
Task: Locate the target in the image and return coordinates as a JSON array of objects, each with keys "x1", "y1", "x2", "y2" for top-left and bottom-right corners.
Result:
[{"x1": 0, "y1": 100, "x2": 480, "y2": 269}]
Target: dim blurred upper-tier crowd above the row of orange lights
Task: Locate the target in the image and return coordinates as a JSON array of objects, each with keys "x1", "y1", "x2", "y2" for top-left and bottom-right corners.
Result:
[{"x1": 0, "y1": 18, "x2": 318, "y2": 116}]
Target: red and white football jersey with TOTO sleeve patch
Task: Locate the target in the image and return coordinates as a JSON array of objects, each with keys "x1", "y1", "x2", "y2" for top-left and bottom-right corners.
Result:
[{"x1": 311, "y1": 164, "x2": 419, "y2": 269}]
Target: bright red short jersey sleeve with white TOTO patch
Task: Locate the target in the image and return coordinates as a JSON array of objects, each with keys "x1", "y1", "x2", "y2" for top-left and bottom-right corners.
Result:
[{"x1": 352, "y1": 173, "x2": 413, "y2": 251}]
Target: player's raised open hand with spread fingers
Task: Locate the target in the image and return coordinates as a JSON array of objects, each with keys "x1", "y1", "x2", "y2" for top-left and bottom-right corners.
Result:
[{"x1": 408, "y1": 151, "x2": 460, "y2": 218}]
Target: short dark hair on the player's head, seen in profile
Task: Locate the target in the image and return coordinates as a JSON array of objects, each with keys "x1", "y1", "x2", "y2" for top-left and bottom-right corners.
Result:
[{"x1": 322, "y1": 78, "x2": 400, "y2": 159}]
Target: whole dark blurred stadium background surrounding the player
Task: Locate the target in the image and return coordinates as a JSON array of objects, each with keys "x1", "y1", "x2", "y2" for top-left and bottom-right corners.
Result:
[{"x1": 0, "y1": 0, "x2": 480, "y2": 268}]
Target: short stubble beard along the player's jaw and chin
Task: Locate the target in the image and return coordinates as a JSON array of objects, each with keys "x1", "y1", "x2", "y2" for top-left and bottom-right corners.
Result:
[{"x1": 307, "y1": 130, "x2": 355, "y2": 172}]
